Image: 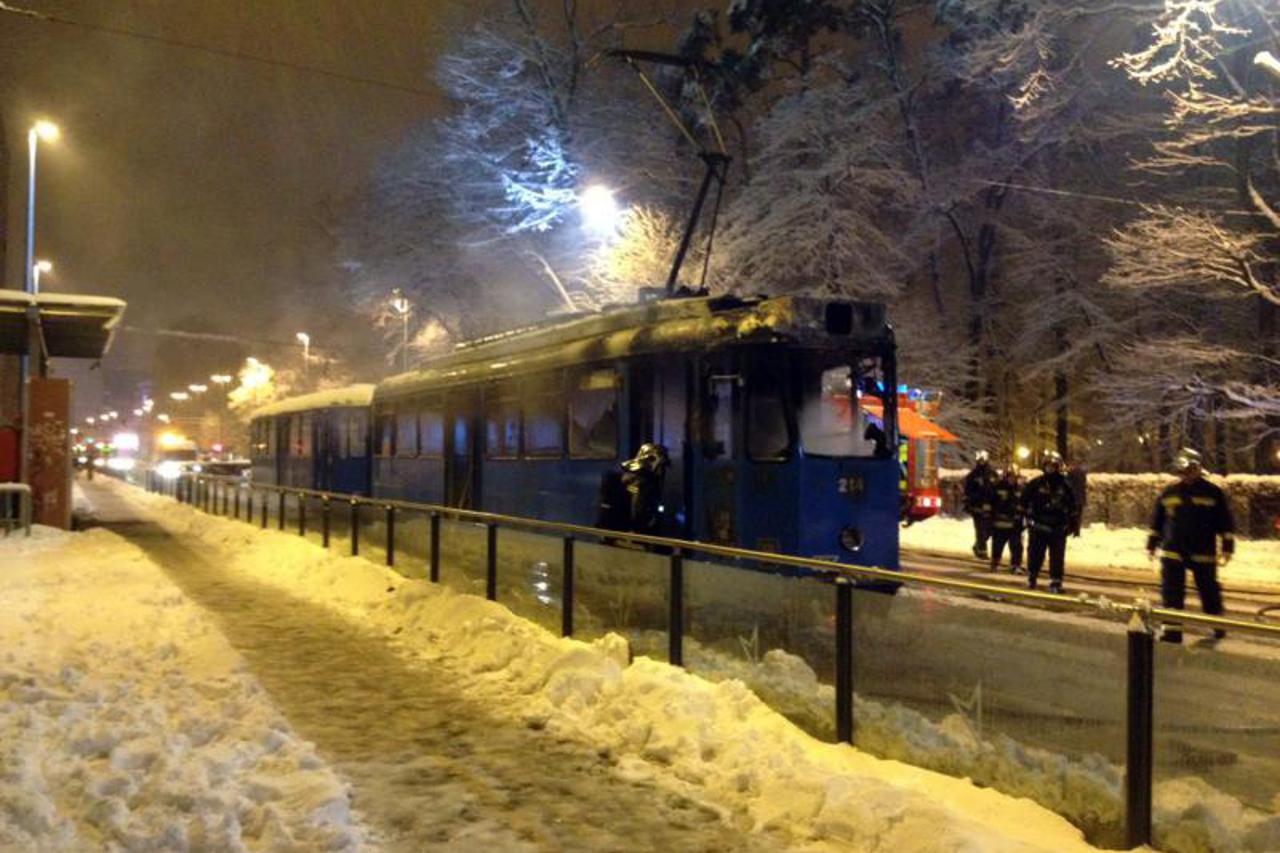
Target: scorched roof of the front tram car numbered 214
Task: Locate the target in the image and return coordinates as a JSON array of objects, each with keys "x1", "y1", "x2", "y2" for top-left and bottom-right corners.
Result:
[{"x1": 374, "y1": 296, "x2": 892, "y2": 401}]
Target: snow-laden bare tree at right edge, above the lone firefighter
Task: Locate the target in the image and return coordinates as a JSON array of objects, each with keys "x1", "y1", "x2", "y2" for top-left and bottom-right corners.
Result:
[{"x1": 1106, "y1": 0, "x2": 1280, "y2": 467}]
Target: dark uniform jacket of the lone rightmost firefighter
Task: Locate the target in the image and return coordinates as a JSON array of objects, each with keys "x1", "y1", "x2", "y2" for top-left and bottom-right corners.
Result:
[{"x1": 1147, "y1": 476, "x2": 1235, "y2": 564}]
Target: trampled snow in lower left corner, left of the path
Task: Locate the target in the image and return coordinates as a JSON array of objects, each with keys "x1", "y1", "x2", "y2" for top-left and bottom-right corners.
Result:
[{"x1": 0, "y1": 526, "x2": 367, "y2": 850}]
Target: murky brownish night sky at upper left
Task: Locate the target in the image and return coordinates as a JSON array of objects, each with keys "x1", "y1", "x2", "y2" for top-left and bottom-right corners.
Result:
[{"x1": 0, "y1": 0, "x2": 477, "y2": 389}]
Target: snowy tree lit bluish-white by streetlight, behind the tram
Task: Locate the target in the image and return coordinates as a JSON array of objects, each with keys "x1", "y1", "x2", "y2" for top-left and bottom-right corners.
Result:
[{"x1": 344, "y1": 0, "x2": 689, "y2": 337}]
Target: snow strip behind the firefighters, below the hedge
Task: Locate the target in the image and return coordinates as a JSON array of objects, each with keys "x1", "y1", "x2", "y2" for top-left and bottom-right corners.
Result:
[{"x1": 901, "y1": 516, "x2": 1280, "y2": 587}]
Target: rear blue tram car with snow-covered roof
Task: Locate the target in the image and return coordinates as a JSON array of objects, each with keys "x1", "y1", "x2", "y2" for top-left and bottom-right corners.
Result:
[{"x1": 250, "y1": 384, "x2": 374, "y2": 494}]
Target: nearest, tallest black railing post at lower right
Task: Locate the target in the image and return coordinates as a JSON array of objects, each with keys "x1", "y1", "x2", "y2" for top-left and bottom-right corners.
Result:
[{"x1": 1124, "y1": 612, "x2": 1156, "y2": 848}]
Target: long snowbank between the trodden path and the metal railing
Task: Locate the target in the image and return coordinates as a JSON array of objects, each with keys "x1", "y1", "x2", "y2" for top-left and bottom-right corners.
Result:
[{"x1": 87, "y1": 483, "x2": 1111, "y2": 852}]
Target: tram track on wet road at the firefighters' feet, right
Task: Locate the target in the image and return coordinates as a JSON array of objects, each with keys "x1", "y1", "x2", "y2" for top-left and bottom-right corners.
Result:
[{"x1": 901, "y1": 548, "x2": 1280, "y2": 624}]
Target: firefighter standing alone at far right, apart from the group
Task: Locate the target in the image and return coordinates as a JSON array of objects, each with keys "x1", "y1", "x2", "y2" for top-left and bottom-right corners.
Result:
[{"x1": 1147, "y1": 448, "x2": 1235, "y2": 643}]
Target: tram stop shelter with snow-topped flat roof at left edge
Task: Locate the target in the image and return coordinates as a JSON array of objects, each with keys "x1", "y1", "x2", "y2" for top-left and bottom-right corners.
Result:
[{"x1": 0, "y1": 289, "x2": 125, "y2": 528}]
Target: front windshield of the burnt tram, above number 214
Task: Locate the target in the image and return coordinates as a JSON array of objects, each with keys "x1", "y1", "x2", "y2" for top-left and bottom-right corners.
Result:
[{"x1": 800, "y1": 359, "x2": 890, "y2": 457}]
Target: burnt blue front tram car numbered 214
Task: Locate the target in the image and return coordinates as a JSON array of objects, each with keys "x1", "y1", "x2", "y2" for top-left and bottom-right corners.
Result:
[{"x1": 255, "y1": 296, "x2": 900, "y2": 567}]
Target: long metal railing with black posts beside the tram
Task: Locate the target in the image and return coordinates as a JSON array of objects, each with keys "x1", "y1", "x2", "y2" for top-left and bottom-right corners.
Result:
[{"x1": 146, "y1": 471, "x2": 1280, "y2": 848}]
